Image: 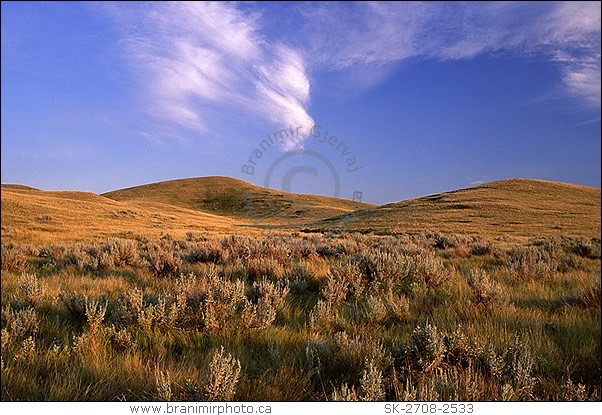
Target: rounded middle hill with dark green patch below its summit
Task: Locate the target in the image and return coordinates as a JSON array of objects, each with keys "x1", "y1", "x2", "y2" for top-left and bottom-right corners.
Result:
[{"x1": 103, "y1": 176, "x2": 375, "y2": 224}]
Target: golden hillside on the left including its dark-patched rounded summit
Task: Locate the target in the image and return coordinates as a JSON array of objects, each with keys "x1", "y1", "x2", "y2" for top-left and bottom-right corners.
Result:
[{"x1": 2, "y1": 177, "x2": 374, "y2": 243}]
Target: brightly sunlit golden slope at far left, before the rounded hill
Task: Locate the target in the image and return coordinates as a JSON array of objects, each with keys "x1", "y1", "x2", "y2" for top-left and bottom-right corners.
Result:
[{"x1": 2, "y1": 185, "x2": 247, "y2": 243}]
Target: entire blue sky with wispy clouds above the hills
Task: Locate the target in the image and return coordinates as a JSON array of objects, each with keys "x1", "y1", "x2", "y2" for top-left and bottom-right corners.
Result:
[{"x1": 1, "y1": 2, "x2": 601, "y2": 204}]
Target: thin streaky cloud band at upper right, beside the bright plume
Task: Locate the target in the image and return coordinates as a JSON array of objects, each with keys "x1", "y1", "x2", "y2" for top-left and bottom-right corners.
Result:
[{"x1": 294, "y1": 2, "x2": 600, "y2": 107}]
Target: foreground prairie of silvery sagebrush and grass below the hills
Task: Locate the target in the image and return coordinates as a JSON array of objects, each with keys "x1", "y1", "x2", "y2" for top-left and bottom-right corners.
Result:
[{"x1": 1, "y1": 232, "x2": 601, "y2": 401}]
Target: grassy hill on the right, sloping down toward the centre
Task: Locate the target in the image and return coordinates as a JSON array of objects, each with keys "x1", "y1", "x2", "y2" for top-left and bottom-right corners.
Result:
[{"x1": 313, "y1": 179, "x2": 600, "y2": 236}]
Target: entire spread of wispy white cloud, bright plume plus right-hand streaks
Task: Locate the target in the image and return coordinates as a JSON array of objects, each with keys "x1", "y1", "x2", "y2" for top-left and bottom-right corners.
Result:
[{"x1": 103, "y1": 2, "x2": 600, "y2": 149}]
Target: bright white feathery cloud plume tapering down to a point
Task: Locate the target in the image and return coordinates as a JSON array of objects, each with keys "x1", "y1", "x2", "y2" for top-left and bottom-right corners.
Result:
[{"x1": 105, "y1": 2, "x2": 314, "y2": 149}]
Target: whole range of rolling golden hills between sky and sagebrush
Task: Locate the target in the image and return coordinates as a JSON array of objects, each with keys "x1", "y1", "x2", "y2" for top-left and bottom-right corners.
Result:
[{"x1": 1, "y1": 177, "x2": 600, "y2": 243}]
